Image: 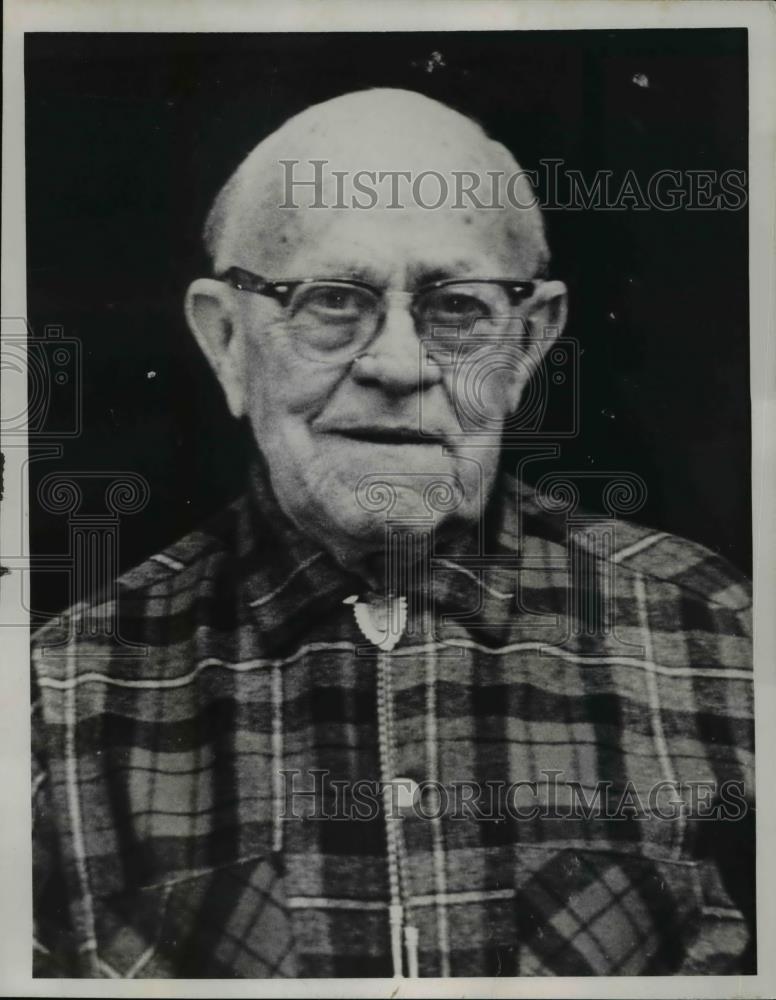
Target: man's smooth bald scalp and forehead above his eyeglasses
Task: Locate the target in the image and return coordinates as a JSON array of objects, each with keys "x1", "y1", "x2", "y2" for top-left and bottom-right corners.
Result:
[{"x1": 208, "y1": 91, "x2": 543, "y2": 274}]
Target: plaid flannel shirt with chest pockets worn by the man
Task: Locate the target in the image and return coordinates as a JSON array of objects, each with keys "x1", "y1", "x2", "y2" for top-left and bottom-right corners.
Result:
[{"x1": 33, "y1": 466, "x2": 754, "y2": 978}]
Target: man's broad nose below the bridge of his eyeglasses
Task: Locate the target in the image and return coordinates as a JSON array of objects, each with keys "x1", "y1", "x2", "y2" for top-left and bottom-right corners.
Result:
[{"x1": 353, "y1": 299, "x2": 442, "y2": 395}]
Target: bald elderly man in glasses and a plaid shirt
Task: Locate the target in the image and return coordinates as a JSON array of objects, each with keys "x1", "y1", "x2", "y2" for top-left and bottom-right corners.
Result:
[{"x1": 33, "y1": 90, "x2": 752, "y2": 977}]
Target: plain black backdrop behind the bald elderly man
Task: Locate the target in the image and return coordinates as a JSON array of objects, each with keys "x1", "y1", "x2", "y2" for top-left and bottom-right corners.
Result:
[{"x1": 25, "y1": 30, "x2": 751, "y2": 613}]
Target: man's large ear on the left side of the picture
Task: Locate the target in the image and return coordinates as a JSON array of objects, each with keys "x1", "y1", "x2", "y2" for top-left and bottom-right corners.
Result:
[{"x1": 185, "y1": 278, "x2": 245, "y2": 419}]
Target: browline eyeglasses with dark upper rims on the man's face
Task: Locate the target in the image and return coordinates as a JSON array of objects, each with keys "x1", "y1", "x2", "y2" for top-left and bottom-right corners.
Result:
[{"x1": 217, "y1": 267, "x2": 540, "y2": 363}]
